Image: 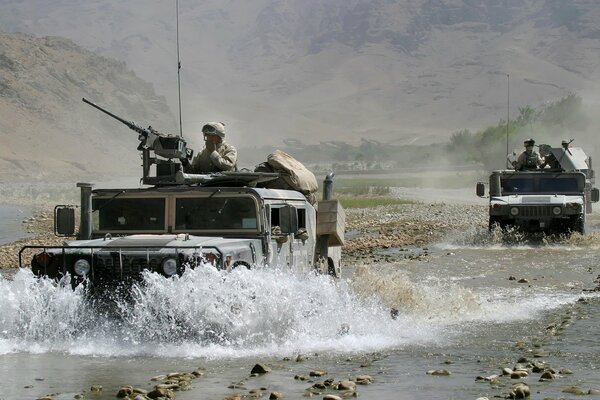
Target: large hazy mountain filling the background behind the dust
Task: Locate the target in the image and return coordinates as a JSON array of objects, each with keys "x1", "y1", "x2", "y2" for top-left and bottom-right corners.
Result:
[{"x1": 0, "y1": 0, "x2": 600, "y2": 167}]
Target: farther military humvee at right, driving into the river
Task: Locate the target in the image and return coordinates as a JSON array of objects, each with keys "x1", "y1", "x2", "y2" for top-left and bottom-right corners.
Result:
[{"x1": 476, "y1": 143, "x2": 599, "y2": 234}]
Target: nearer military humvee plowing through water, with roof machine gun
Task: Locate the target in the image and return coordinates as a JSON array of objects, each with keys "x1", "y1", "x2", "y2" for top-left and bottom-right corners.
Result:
[{"x1": 19, "y1": 101, "x2": 345, "y2": 287}]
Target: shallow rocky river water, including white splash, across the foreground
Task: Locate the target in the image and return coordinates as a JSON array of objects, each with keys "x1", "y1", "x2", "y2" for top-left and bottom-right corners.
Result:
[{"x1": 0, "y1": 214, "x2": 600, "y2": 400}]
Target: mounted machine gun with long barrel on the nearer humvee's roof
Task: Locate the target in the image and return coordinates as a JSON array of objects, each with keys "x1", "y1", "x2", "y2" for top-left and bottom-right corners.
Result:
[{"x1": 82, "y1": 98, "x2": 194, "y2": 185}]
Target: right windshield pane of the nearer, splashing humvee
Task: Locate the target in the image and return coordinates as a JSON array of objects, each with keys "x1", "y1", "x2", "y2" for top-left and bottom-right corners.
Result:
[{"x1": 175, "y1": 196, "x2": 258, "y2": 230}]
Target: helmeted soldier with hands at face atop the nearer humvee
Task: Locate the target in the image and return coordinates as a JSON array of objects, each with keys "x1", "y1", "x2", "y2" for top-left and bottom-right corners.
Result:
[{"x1": 181, "y1": 122, "x2": 237, "y2": 174}]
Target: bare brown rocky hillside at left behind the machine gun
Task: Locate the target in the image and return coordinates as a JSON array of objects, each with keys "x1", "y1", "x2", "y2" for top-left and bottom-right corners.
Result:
[{"x1": 0, "y1": 32, "x2": 177, "y2": 181}]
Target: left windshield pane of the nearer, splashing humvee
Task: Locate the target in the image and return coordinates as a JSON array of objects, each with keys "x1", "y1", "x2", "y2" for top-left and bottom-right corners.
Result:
[{"x1": 92, "y1": 198, "x2": 165, "y2": 231}]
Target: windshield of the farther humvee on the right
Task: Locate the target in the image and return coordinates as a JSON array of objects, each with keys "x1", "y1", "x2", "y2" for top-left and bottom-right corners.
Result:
[{"x1": 500, "y1": 177, "x2": 580, "y2": 195}]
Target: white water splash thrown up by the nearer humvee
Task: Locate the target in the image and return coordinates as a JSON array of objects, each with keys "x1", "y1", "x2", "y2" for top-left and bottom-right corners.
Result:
[{"x1": 0, "y1": 267, "x2": 438, "y2": 358}]
